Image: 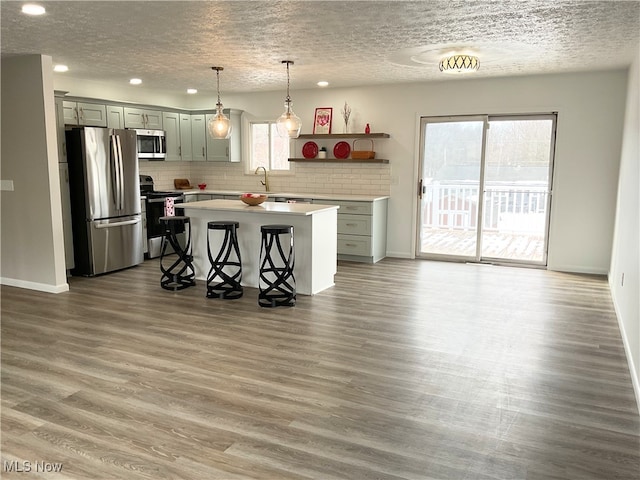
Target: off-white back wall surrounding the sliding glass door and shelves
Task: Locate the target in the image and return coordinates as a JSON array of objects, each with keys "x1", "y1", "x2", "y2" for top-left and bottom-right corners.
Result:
[{"x1": 56, "y1": 70, "x2": 627, "y2": 274}]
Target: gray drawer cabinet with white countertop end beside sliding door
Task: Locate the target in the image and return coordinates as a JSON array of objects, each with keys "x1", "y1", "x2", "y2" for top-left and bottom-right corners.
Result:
[{"x1": 313, "y1": 198, "x2": 388, "y2": 263}]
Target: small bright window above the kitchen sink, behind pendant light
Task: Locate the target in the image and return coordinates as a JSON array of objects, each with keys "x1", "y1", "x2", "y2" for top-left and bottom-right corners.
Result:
[{"x1": 249, "y1": 122, "x2": 289, "y2": 171}]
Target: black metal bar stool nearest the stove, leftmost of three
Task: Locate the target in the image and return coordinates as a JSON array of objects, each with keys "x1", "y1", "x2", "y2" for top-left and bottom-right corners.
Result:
[{"x1": 160, "y1": 216, "x2": 196, "y2": 291}]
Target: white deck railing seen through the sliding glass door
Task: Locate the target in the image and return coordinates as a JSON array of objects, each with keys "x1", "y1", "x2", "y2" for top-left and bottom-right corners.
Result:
[{"x1": 422, "y1": 182, "x2": 549, "y2": 232}]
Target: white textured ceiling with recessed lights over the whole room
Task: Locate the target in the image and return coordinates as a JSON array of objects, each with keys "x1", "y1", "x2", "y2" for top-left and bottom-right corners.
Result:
[{"x1": 0, "y1": 0, "x2": 640, "y2": 93}]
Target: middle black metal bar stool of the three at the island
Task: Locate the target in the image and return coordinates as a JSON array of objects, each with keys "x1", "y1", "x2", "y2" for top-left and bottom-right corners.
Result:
[{"x1": 207, "y1": 221, "x2": 243, "y2": 299}]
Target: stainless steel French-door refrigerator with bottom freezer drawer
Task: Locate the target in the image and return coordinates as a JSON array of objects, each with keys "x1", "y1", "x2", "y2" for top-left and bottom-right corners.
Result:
[{"x1": 66, "y1": 127, "x2": 144, "y2": 276}]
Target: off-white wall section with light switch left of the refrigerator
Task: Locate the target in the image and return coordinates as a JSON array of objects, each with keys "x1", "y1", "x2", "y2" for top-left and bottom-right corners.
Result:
[{"x1": 0, "y1": 55, "x2": 69, "y2": 292}]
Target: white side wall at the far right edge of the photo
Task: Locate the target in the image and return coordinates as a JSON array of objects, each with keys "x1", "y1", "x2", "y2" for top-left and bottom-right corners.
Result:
[{"x1": 609, "y1": 47, "x2": 640, "y2": 410}]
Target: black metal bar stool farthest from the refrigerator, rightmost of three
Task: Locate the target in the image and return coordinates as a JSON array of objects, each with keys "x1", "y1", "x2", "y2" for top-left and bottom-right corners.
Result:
[{"x1": 258, "y1": 225, "x2": 296, "y2": 307}]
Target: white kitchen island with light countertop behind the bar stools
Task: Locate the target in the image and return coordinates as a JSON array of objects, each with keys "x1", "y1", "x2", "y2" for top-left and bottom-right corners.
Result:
[{"x1": 180, "y1": 200, "x2": 338, "y2": 295}]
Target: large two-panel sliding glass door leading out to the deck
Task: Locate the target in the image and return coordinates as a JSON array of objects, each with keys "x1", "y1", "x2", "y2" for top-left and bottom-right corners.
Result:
[{"x1": 417, "y1": 114, "x2": 555, "y2": 265}]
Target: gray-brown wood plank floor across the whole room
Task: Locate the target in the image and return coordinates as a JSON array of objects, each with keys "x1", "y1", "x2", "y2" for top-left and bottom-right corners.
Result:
[{"x1": 1, "y1": 259, "x2": 640, "y2": 480}]
